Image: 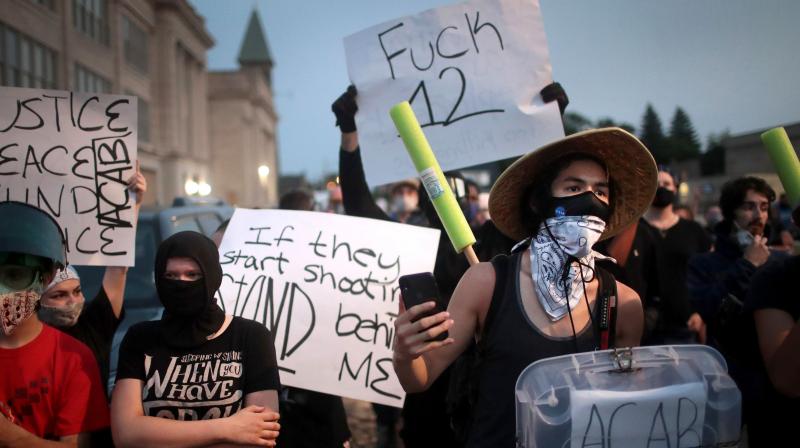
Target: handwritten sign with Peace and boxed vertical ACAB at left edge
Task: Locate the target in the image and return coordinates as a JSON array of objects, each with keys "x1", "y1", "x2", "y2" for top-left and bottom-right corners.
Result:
[{"x1": 0, "y1": 87, "x2": 137, "y2": 266}]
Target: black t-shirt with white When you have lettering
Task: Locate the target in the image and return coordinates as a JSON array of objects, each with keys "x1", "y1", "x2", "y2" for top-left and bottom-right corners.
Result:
[{"x1": 117, "y1": 317, "x2": 280, "y2": 420}]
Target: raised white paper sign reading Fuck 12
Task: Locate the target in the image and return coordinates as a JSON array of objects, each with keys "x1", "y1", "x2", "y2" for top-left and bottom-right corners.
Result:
[{"x1": 344, "y1": 0, "x2": 564, "y2": 186}]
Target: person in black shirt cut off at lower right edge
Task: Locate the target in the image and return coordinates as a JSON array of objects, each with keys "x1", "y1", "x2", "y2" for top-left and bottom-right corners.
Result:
[{"x1": 740, "y1": 256, "x2": 800, "y2": 447}]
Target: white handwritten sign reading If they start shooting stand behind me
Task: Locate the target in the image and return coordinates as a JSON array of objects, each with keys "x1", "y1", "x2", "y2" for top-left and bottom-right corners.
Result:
[{"x1": 218, "y1": 209, "x2": 439, "y2": 407}]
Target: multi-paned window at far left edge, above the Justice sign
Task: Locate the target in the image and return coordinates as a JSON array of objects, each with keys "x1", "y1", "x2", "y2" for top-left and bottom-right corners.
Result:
[{"x1": 0, "y1": 23, "x2": 56, "y2": 89}]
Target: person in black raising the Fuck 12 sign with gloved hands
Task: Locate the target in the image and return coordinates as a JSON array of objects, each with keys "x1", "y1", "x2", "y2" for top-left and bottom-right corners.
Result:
[{"x1": 331, "y1": 83, "x2": 569, "y2": 447}]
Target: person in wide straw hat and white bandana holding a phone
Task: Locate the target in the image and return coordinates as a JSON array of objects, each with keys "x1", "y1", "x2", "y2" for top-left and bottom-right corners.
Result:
[{"x1": 393, "y1": 128, "x2": 657, "y2": 447}]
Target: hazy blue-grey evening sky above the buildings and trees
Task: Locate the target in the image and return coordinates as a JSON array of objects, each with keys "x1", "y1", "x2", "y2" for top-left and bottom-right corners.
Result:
[{"x1": 191, "y1": 0, "x2": 800, "y2": 179}]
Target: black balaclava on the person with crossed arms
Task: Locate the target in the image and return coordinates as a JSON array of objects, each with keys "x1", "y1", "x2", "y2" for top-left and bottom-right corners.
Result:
[{"x1": 155, "y1": 231, "x2": 225, "y2": 348}]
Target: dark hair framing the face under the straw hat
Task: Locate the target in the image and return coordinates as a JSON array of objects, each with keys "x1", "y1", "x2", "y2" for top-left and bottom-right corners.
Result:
[{"x1": 519, "y1": 153, "x2": 617, "y2": 237}]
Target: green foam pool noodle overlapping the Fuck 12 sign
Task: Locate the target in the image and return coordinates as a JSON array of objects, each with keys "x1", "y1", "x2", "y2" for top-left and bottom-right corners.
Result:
[{"x1": 389, "y1": 101, "x2": 475, "y2": 252}]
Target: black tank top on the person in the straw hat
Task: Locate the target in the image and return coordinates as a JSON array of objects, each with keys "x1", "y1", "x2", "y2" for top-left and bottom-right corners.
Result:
[{"x1": 466, "y1": 252, "x2": 602, "y2": 448}]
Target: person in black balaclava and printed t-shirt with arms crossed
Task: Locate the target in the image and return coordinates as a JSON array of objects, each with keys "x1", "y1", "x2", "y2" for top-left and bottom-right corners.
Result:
[{"x1": 111, "y1": 232, "x2": 280, "y2": 446}]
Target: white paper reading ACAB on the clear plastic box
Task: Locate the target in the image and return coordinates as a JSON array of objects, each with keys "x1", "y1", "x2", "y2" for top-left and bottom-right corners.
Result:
[{"x1": 570, "y1": 383, "x2": 706, "y2": 448}]
